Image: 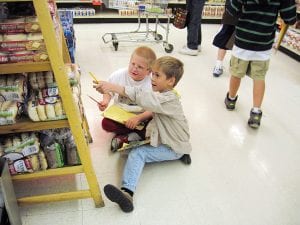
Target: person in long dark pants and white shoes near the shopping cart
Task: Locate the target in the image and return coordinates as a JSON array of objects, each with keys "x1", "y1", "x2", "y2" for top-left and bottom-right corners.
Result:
[{"x1": 179, "y1": 0, "x2": 205, "y2": 56}]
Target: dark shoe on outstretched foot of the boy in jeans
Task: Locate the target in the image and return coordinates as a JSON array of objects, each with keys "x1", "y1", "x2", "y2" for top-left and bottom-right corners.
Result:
[{"x1": 104, "y1": 184, "x2": 133, "y2": 212}]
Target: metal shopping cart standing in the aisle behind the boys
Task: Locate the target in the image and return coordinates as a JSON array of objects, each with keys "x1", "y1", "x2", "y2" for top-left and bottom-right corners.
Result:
[{"x1": 102, "y1": 0, "x2": 174, "y2": 53}]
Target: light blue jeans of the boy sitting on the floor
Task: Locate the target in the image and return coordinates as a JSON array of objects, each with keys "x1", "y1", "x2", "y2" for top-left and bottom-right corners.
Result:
[{"x1": 122, "y1": 145, "x2": 183, "y2": 192}]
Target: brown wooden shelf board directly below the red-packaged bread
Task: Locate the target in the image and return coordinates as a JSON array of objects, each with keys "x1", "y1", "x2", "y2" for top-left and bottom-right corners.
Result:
[{"x1": 0, "y1": 62, "x2": 51, "y2": 74}]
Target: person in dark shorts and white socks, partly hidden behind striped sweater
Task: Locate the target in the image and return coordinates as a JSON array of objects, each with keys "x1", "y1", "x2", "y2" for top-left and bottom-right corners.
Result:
[{"x1": 213, "y1": 0, "x2": 238, "y2": 77}]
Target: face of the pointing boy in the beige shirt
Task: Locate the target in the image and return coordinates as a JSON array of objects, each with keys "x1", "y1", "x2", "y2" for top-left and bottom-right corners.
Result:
[{"x1": 151, "y1": 67, "x2": 175, "y2": 92}]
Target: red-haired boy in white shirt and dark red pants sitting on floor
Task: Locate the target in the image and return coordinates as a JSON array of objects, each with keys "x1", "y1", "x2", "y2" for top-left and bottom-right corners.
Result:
[{"x1": 98, "y1": 46, "x2": 156, "y2": 152}]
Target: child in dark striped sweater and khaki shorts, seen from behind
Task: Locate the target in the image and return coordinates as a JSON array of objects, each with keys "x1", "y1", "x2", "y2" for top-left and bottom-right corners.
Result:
[{"x1": 225, "y1": 0, "x2": 296, "y2": 128}]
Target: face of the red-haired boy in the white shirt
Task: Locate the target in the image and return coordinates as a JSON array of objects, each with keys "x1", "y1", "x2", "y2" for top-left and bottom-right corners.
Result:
[{"x1": 128, "y1": 54, "x2": 150, "y2": 81}]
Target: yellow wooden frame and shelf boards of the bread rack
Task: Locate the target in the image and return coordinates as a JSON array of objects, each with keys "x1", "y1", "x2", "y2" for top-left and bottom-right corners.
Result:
[{"x1": 0, "y1": 0, "x2": 104, "y2": 207}]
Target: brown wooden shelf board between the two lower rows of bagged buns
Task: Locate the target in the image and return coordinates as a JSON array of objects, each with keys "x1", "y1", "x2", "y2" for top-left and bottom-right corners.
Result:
[{"x1": 0, "y1": 118, "x2": 69, "y2": 134}]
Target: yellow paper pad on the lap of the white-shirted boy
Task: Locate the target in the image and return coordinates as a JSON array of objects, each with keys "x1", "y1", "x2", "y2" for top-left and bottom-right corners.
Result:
[{"x1": 103, "y1": 105, "x2": 144, "y2": 130}]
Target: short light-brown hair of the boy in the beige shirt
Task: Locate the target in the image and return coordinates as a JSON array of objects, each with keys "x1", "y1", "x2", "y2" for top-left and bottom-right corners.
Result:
[{"x1": 151, "y1": 56, "x2": 184, "y2": 87}]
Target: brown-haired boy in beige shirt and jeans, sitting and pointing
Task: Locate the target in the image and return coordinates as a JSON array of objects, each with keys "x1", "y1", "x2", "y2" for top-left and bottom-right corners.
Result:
[{"x1": 94, "y1": 56, "x2": 192, "y2": 212}]
